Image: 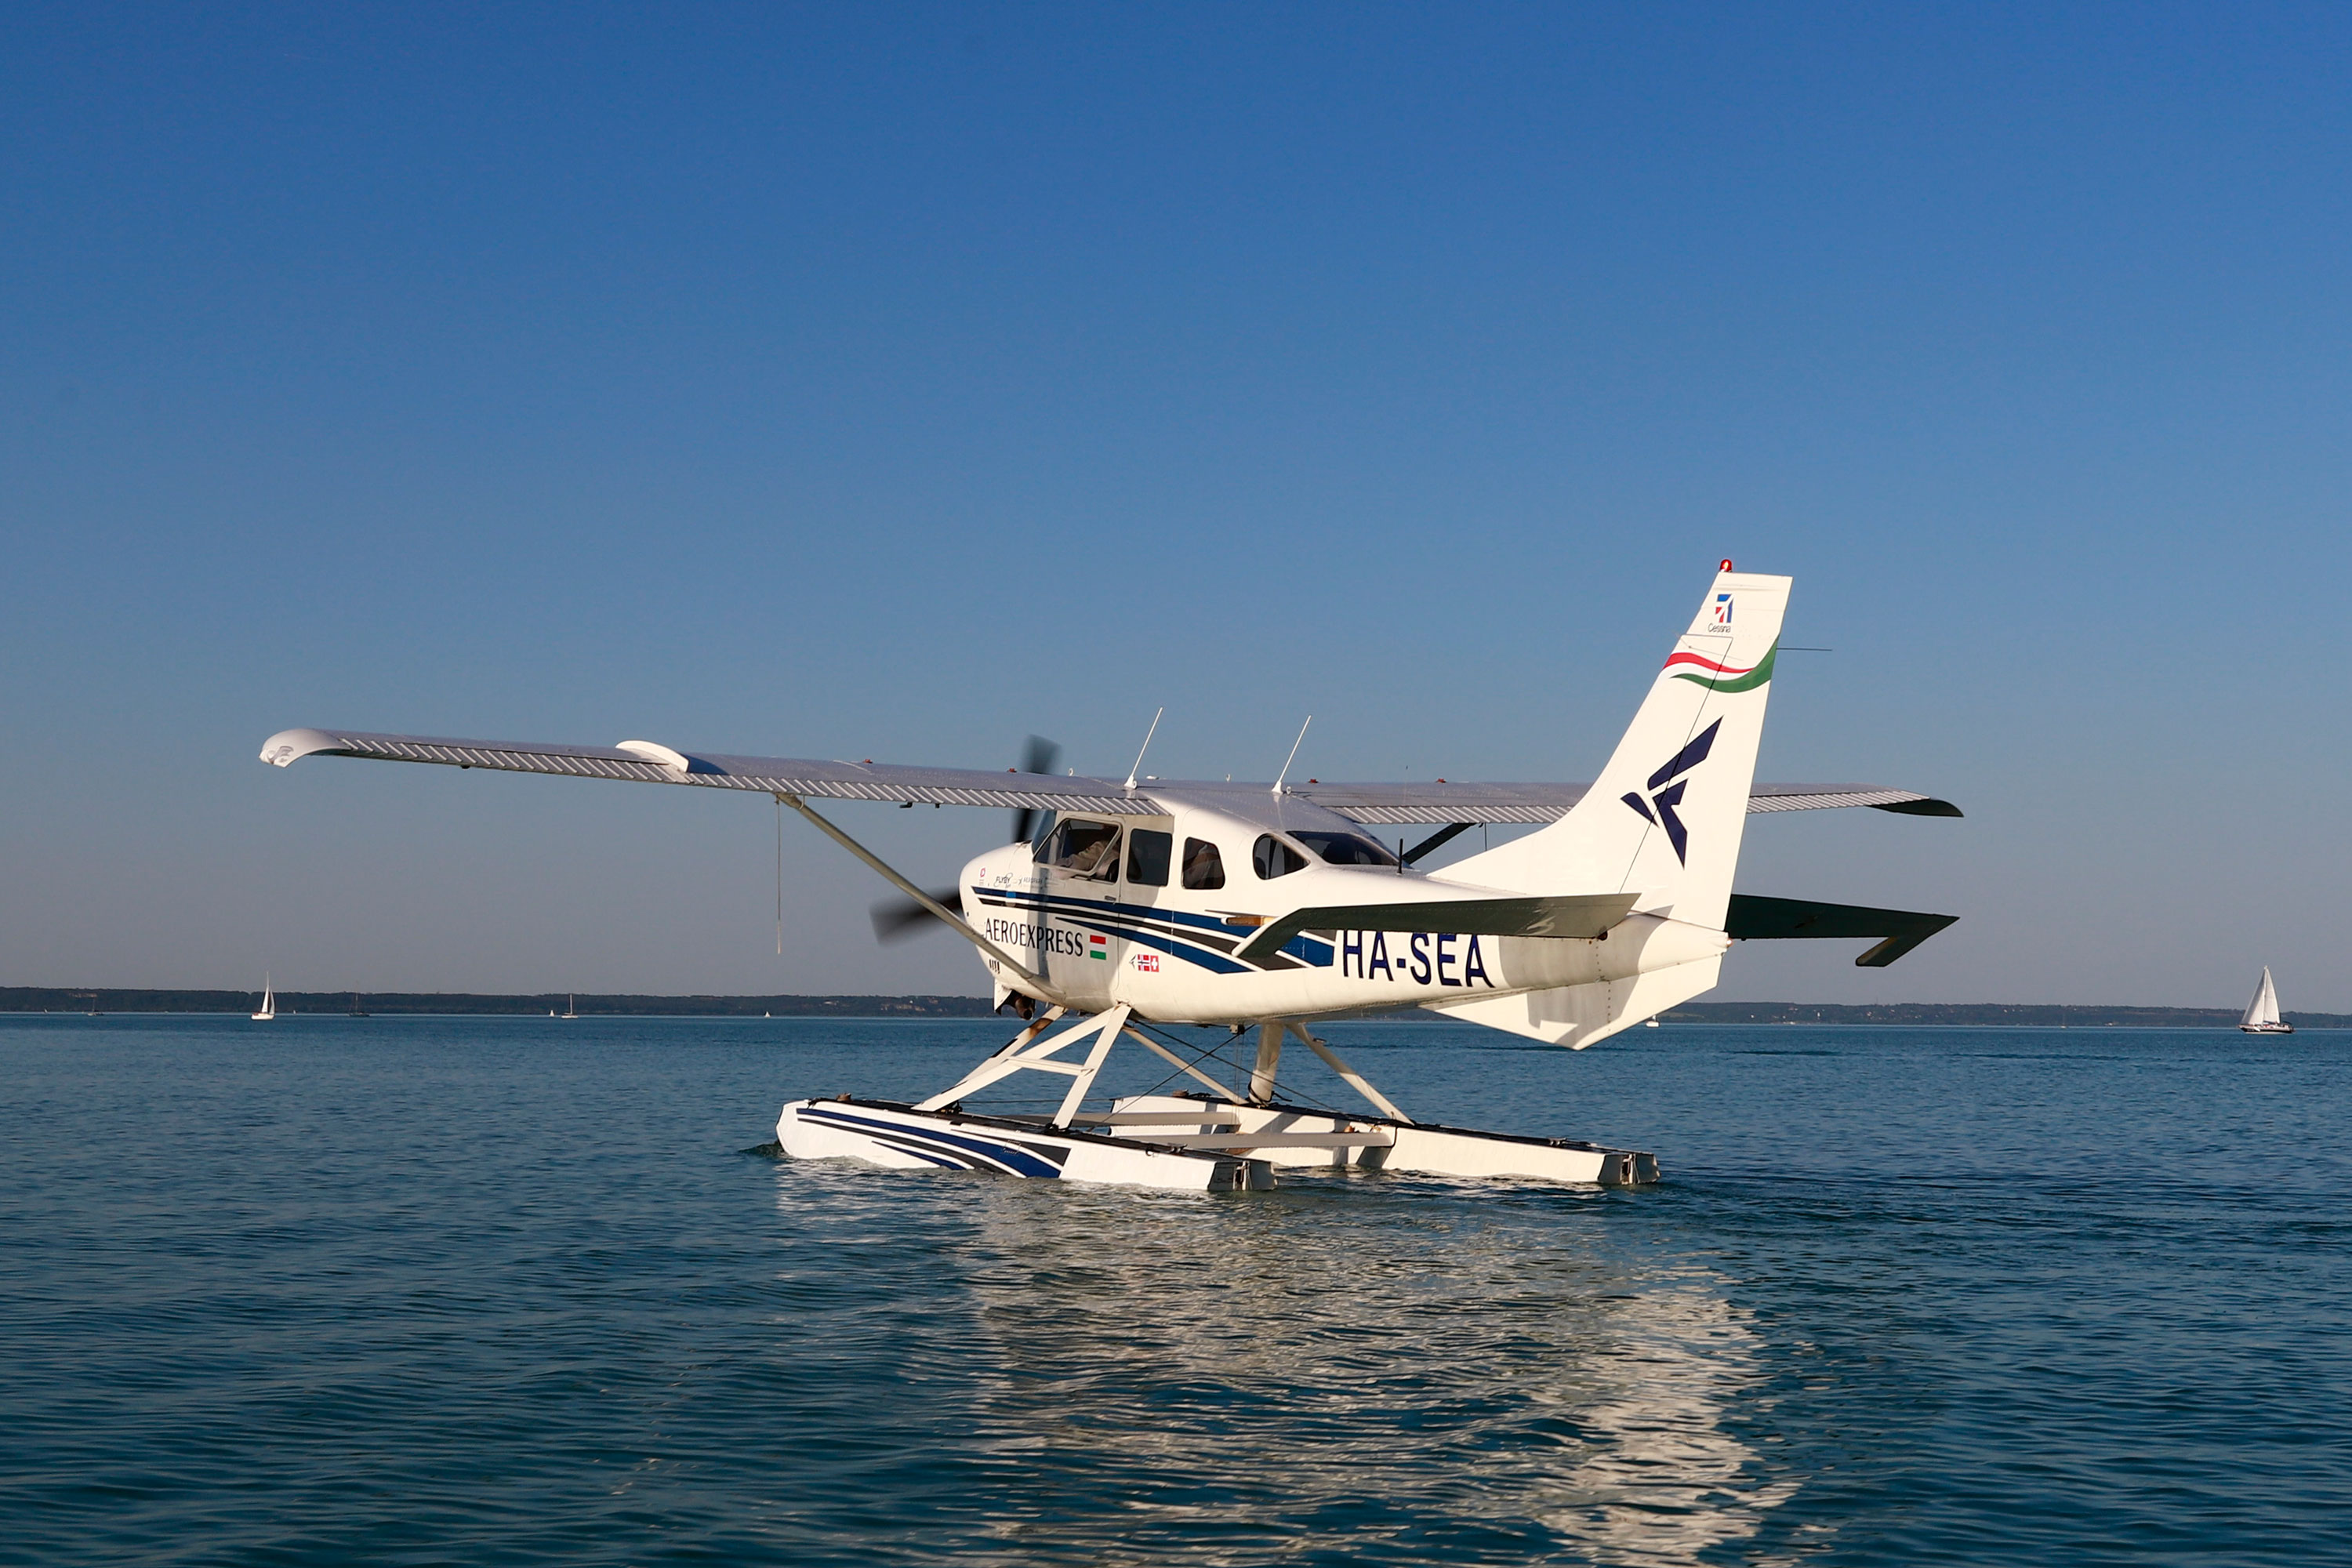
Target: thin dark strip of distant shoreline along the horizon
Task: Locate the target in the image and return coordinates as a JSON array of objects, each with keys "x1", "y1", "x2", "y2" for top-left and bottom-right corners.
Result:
[{"x1": 0, "y1": 985, "x2": 2352, "y2": 1029}]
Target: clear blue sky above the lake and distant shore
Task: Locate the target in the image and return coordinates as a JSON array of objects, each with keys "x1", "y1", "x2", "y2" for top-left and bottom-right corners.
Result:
[{"x1": 0, "y1": 2, "x2": 2352, "y2": 1011}]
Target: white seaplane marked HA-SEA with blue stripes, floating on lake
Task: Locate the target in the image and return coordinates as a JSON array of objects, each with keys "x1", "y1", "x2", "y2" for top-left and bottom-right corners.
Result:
[{"x1": 261, "y1": 560, "x2": 1959, "y2": 1192}]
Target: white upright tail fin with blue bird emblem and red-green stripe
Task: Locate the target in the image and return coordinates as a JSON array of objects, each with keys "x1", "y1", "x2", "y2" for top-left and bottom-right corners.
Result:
[{"x1": 1444, "y1": 562, "x2": 1790, "y2": 931}]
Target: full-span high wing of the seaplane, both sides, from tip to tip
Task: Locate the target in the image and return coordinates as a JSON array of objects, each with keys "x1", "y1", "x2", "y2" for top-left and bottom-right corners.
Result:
[{"x1": 261, "y1": 729, "x2": 1959, "y2": 825}]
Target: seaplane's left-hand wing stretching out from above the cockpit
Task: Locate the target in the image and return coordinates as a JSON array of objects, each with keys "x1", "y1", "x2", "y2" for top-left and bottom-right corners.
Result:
[{"x1": 261, "y1": 729, "x2": 1160, "y2": 815}]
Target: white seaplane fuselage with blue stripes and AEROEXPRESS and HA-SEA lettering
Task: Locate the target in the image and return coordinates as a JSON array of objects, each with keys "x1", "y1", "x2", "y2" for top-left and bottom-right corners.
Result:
[{"x1": 960, "y1": 785, "x2": 1729, "y2": 1022}]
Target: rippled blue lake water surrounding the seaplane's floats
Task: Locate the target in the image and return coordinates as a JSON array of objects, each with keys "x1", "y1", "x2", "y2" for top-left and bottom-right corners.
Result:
[{"x1": 0, "y1": 1015, "x2": 2352, "y2": 1568}]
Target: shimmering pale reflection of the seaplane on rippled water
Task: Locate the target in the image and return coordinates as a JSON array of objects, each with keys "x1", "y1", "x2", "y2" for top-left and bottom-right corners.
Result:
[{"x1": 779, "y1": 1163, "x2": 1799, "y2": 1568}]
